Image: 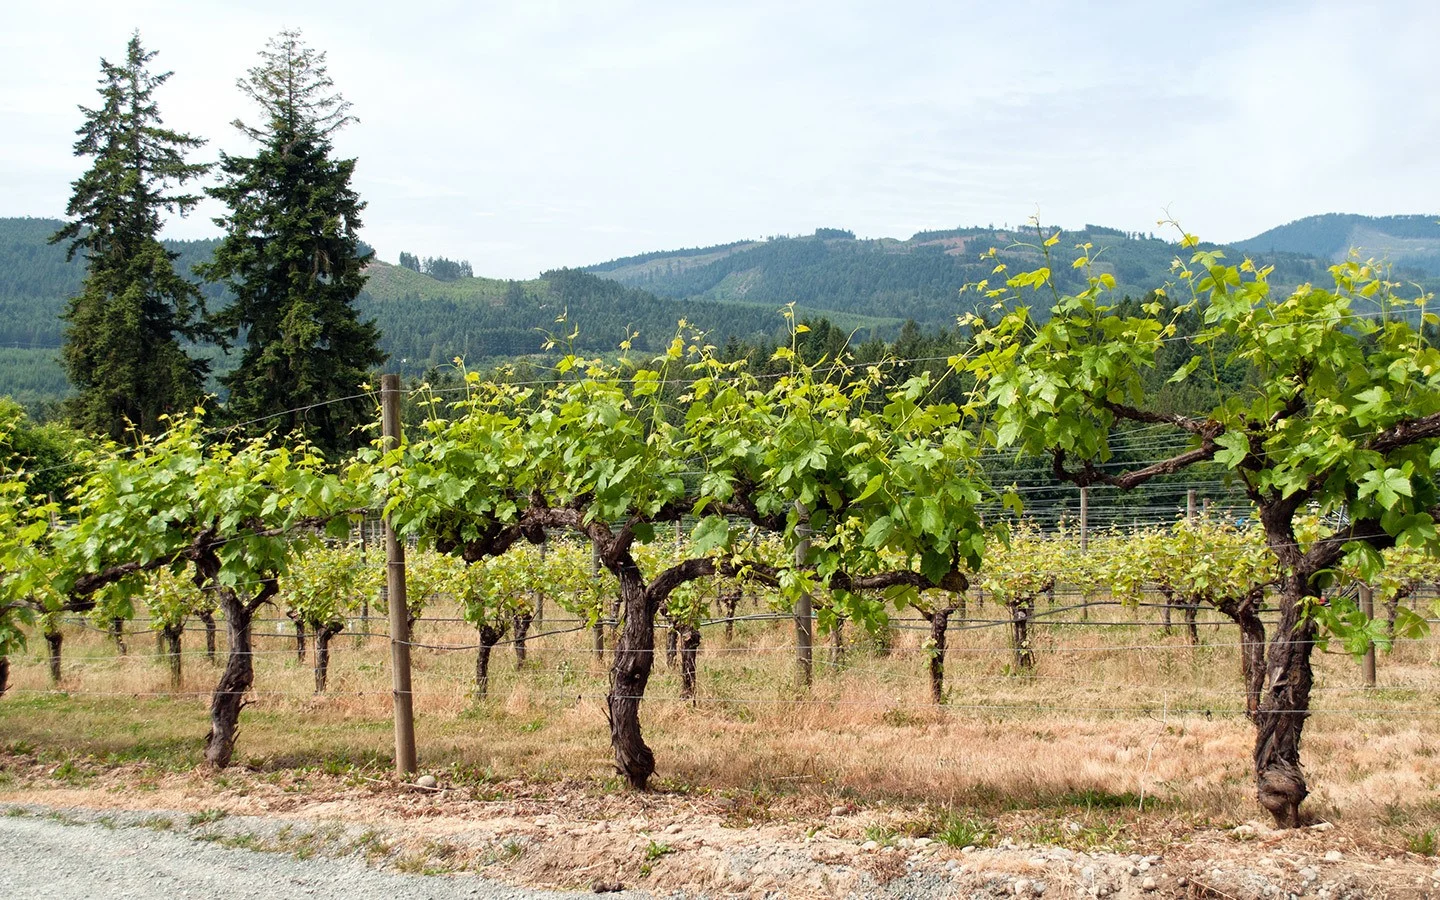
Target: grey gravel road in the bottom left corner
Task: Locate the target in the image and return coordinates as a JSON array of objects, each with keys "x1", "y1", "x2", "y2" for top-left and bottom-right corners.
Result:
[{"x1": 0, "y1": 815, "x2": 649, "y2": 900}]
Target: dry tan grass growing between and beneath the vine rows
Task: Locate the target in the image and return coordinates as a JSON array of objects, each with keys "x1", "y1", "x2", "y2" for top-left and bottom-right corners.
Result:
[{"x1": 0, "y1": 593, "x2": 1440, "y2": 838}]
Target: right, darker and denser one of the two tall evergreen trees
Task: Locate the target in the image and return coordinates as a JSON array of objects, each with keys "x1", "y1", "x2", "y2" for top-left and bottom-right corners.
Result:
[{"x1": 202, "y1": 32, "x2": 384, "y2": 451}]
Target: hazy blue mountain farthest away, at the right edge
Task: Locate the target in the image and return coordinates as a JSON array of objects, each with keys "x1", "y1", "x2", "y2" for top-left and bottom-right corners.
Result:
[{"x1": 1234, "y1": 213, "x2": 1440, "y2": 275}]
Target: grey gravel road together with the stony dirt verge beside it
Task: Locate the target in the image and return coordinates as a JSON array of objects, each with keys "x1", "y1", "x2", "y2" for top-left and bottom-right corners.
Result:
[{"x1": 0, "y1": 757, "x2": 1440, "y2": 900}]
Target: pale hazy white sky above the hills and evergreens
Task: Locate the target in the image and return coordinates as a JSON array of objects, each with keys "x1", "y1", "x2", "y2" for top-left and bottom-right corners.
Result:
[{"x1": 0, "y1": 0, "x2": 1440, "y2": 278}]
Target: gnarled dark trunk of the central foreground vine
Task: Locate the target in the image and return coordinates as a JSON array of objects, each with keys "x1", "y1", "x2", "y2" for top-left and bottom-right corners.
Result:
[{"x1": 606, "y1": 556, "x2": 657, "y2": 791}]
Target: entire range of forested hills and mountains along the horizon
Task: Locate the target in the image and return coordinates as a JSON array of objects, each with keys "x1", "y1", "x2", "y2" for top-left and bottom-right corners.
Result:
[{"x1": 0, "y1": 215, "x2": 1440, "y2": 403}]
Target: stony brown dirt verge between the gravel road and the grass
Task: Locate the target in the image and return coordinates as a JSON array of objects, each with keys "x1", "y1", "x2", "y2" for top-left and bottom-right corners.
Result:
[{"x1": 0, "y1": 753, "x2": 1440, "y2": 900}]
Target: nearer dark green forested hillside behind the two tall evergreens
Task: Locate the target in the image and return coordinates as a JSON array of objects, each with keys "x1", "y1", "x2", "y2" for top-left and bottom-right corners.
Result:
[{"x1": 0, "y1": 219, "x2": 903, "y2": 406}]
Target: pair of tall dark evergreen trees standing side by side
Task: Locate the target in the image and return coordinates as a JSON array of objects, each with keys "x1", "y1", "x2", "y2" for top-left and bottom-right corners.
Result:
[{"x1": 50, "y1": 32, "x2": 386, "y2": 449}]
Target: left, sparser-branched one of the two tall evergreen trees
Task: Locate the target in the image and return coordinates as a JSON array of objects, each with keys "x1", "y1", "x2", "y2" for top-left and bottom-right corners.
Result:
[{"x1": 50, "y1": 33, "x2": 209, "y2": 438}]
